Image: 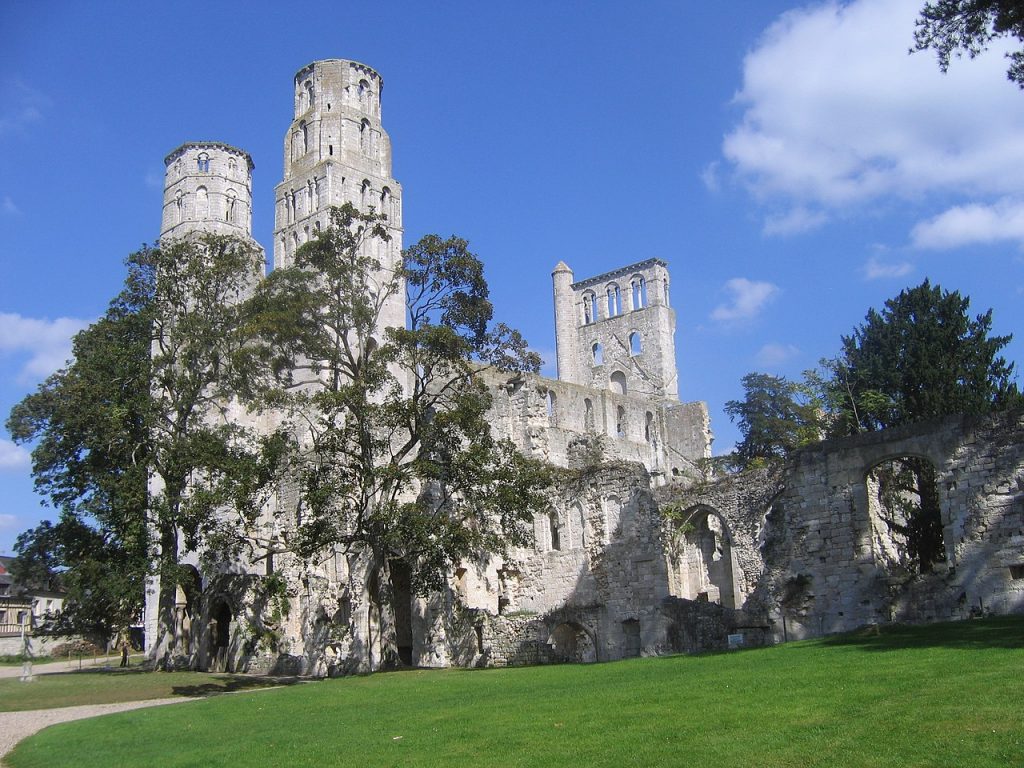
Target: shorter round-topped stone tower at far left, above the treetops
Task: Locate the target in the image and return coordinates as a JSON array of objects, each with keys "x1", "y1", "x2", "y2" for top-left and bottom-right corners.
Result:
[{"x1": 160, "y1": 141, "x2": 253, "y2": 239}]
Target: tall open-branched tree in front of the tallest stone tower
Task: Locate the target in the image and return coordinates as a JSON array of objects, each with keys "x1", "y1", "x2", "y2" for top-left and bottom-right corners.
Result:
[{"x1": 250, "y1": 204, "x2": 547, "y2": 667}]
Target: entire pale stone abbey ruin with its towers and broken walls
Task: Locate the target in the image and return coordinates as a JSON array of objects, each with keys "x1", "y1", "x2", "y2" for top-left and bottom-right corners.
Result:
[{"x1": 145, "y1": 59, "x2": 1024, "y2": 675}]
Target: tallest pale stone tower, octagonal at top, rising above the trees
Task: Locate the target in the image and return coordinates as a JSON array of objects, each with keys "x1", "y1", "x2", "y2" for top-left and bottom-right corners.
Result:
[{"x1": 273, "y1": 58, "x2": 406, "y2": 327}]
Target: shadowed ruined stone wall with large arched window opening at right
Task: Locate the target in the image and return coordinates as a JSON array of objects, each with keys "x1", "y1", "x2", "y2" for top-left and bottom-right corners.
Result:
[{"x1": 673, "y1": 412, "x2": 1024, "y2": 640}]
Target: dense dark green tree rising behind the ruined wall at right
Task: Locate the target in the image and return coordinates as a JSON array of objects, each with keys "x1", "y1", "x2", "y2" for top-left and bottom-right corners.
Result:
[{"x1": 827, "y1": 280, "x2": 1021, "y2": 434}]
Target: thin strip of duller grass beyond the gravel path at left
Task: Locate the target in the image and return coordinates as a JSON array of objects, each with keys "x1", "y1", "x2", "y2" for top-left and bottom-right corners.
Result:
[{"x1": 0, "y1": 667, "x2": 299, "y2": 712}]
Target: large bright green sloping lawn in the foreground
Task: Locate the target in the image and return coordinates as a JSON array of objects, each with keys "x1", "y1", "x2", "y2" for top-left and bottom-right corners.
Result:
[{"x1": 8, "y1": 618, "x2": 1024, "y2": 768}]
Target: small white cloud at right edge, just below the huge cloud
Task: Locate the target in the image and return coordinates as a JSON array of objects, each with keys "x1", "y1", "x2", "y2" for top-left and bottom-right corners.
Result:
[{"x1": 910, "y1": 198, "x2": 1024, "y2": 249}]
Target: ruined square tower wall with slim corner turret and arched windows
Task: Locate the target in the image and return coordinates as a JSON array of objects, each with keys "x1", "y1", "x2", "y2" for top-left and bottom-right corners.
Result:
[{"x1": 552, "y1": 259, "x2": 679, "y2": 400}]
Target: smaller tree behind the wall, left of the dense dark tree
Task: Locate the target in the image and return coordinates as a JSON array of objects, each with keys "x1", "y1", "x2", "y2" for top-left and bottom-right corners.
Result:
[{"x1": 725, "y1": 373, "x2": 820, "y2": 469}]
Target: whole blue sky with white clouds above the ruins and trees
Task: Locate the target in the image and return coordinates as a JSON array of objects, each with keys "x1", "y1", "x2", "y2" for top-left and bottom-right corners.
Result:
[{"x1": 0, "y1": 0, "x2": 1024, "y2": 553}]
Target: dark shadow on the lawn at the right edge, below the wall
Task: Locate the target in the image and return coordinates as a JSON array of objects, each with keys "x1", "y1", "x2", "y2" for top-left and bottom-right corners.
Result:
[{"x1": 819, "y1": 616, "x2": 1024, "y2": 651}]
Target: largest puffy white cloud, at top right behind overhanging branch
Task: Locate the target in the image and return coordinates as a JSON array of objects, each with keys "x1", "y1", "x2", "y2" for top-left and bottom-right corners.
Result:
[{"x1": 722, "y1": 0, "x2": 1024, "y2": 234}]
